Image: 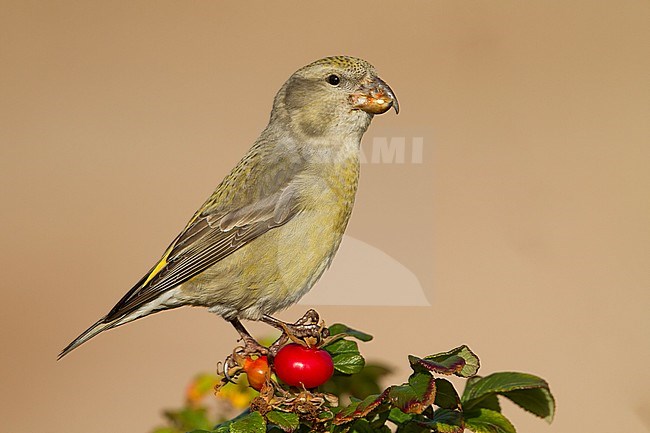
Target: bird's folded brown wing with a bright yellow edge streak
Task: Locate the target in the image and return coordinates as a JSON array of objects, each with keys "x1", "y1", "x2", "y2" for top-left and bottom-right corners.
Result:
[{"x1": 104, "y1": 184, "x2": 299, "y2": 321}]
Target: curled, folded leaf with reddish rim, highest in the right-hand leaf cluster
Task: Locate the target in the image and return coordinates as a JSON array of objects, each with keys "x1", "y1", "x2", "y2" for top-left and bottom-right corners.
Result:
[{"x1": 409, "y1": 345, "x2": 480, "y2": 377}]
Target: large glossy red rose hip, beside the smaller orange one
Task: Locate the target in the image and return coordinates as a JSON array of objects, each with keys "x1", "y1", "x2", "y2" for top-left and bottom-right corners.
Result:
[{"x1": 273, "y1": 343, "x2": 334, "y2": 388}]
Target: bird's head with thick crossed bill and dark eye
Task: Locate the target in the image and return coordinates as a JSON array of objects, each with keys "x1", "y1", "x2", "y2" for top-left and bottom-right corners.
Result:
[{"x1": 271, "y1": 56, "x2": 399, "y2": 136}]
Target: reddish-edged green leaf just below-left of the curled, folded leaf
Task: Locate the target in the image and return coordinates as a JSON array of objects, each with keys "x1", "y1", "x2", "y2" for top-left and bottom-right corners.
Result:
[{"x1": 387, "y1": 373, "x2": 436, "y2": 414}]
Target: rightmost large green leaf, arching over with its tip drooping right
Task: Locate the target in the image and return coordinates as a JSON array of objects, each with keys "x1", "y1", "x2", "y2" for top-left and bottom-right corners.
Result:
[{"x1": 461, "y1": 372, "x2": 555, "y2": 422}]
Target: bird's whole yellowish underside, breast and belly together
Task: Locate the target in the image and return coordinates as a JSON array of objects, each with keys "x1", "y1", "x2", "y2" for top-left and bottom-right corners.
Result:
[{"x1": 177, "y1": 150, "x2": 359, "y2": 319}]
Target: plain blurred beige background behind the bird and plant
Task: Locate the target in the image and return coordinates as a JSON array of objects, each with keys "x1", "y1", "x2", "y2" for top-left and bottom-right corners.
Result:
[{"x1": 0, "y1": 0, "x2": 650, "y2": 433}]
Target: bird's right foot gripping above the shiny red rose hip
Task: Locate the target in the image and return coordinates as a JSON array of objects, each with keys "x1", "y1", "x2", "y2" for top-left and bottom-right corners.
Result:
[{"x1": 261, "y1": 310, "x2": 329, "y2": 355}]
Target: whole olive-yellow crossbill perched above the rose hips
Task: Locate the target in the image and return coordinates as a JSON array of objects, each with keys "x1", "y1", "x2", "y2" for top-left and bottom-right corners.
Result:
[{"x1": 58, "y1": 56, "x2": 399, "y2": 359}]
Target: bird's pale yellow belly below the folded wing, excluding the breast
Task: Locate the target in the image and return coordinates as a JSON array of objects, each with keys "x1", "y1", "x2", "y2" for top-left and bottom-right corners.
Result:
[{"x1": 181, "y1": 206, "x2": 349, "y2": 320}]
